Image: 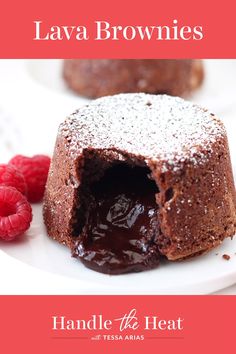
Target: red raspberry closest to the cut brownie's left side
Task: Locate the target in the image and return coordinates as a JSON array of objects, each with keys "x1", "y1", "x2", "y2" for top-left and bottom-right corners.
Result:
[{"x1": 9, "y1": 155, "x2": 50, "y2": 203}]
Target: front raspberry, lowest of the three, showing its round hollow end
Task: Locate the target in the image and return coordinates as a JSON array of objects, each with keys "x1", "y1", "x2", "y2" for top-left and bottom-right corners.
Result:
[{"x1": 0, "y1": 186, "x2": 32, "y2": 241}]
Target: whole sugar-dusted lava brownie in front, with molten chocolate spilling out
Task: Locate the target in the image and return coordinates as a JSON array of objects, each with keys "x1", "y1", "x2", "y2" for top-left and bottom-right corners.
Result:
[{"x1": 44, "y1": 93, "x2": 236, "y2": 274}]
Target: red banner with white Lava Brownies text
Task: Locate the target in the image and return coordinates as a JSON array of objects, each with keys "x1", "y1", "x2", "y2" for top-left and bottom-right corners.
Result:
[{"x1": 0, "y1": 0, "x2": 236, "y2": 58}]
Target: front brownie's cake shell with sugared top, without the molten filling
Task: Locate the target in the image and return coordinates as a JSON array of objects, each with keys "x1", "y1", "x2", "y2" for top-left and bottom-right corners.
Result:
[{"x1": 44, "y1": 94, "x2": 236, "y2": 266}]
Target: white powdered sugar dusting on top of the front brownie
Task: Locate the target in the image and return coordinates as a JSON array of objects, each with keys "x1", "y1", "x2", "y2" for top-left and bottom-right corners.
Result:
[{"x1": 59, "y1": 93, "x2": 226, "y2": 171}]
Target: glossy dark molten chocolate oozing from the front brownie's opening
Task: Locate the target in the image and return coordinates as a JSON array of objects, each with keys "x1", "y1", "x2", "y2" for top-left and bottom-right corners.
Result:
[{"x1": 73, "y1": 165, "x2": 160, "y2": 274}]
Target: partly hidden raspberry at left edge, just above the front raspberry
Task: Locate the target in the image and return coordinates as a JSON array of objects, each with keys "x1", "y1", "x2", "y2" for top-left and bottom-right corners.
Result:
[{"x1": 0, "y1": 164, "x2": 27, "y2": 195}]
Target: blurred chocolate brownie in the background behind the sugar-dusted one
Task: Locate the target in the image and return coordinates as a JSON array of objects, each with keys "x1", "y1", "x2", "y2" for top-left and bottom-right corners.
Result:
[{"x1": 63, "y1": 59, "x2": 203, "y2": 98}]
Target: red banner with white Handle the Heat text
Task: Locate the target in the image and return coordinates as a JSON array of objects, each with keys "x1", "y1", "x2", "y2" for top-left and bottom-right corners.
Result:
[{"x1": 0, "y1": 296, "x2": 232, "y2": 354}]
